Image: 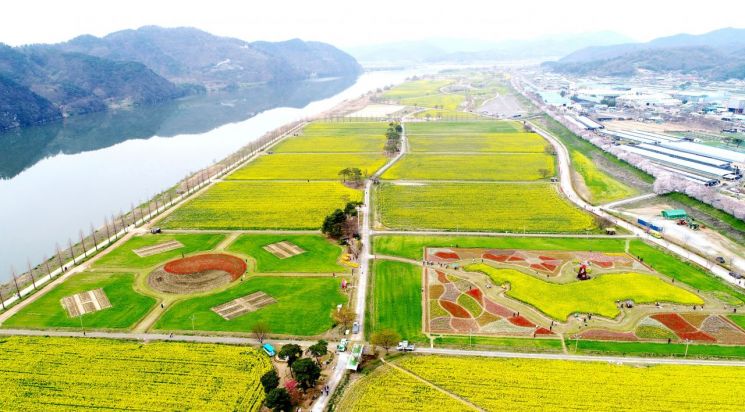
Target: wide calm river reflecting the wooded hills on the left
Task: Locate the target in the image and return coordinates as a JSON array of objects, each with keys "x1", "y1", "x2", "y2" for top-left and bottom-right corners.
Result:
[{"x1": 0, "y1": 70, "x2": 416, "y2": 281}]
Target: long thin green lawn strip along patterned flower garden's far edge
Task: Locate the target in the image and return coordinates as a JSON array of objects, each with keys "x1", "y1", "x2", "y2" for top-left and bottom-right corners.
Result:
[{"x1": 372, "y1": 235, "x2": 626, "y2": 260}]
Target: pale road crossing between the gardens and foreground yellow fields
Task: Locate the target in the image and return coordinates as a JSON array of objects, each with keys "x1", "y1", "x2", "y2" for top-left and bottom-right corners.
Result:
[{"x1": 0, "y1": 329, "x2": 745, "y2": 368}]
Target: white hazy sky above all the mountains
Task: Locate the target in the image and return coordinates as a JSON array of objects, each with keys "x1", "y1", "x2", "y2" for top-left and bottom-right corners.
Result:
[{"x1": 0, "y1": 0, "x2": 745, "y2": 47}]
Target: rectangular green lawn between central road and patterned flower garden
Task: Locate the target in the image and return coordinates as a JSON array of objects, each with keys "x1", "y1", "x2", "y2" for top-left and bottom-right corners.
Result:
[{"x1": 368, "y1": 260, "x2": 426, "y2": 341}]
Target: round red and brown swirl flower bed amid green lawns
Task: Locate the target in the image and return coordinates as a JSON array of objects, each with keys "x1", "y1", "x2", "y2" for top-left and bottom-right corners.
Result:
[{"x1": 148, "y1": 254, "x2": 246, "y2": 294}]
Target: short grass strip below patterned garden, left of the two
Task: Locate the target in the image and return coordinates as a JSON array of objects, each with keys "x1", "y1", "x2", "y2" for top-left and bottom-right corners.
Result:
[{"x1": 435, "y1": 335, "x2": 562, "y2": 352}]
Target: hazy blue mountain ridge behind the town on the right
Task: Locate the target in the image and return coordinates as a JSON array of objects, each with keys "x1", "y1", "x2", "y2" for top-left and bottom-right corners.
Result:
[{"x1": 543, "y1": 28, "x2": 745, "y2": 80}]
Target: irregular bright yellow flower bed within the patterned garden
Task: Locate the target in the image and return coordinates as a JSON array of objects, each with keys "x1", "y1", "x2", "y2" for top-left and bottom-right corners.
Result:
[{"x1": 465, "y1": 263, "x2": 704, "y2": 321}]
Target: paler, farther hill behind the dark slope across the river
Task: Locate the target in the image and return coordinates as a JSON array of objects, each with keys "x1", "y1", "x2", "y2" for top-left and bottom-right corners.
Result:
[{"x1": 54, "y1": 26, "x2": 362, "y2": 89}]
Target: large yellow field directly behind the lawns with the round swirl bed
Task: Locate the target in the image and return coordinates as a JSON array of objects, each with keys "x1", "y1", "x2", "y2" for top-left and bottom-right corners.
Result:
[{"x1": 163, "y1": 181, "x2": 362, "y2": 229}]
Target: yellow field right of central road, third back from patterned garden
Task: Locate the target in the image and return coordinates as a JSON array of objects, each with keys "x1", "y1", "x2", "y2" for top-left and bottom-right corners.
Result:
[{"x1": 406, "y1": 132, "x2": 546, "y2": 153}]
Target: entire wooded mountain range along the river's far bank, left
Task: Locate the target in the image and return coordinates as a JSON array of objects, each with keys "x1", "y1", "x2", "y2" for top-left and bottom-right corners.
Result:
[{"x1": 0, "y1": 26, "x2": 362, "y2": 130}]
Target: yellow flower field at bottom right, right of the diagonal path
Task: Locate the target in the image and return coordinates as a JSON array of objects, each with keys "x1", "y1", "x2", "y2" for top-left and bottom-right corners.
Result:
[{"x1": 386, "y1": 356, "x2": 744, "y2": 411}]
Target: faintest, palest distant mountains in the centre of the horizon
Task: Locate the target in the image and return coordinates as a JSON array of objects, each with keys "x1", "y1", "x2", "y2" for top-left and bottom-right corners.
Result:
[{"x1": 346, "y1": 31, "x2": 631, "y2": 63}]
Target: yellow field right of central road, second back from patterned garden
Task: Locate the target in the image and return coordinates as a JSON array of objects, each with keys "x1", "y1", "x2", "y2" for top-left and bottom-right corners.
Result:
[{"x1": 382, "y1": 153, "x2": 554, "y2": 181}]
